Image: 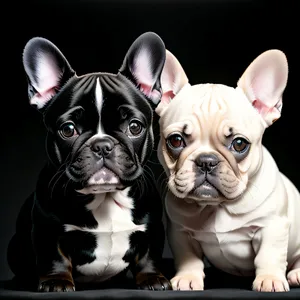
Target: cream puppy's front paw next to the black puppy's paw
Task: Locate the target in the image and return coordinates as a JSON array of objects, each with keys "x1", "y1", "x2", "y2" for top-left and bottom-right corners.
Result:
[{"x1": 171, "y1": 273, "x2": 204, "y2": 291}]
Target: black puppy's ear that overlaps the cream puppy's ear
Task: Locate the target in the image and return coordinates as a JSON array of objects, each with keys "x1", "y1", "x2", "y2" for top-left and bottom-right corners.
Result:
[{"x1": 119, "y1": 32, "x2": 166, "y2": 104}]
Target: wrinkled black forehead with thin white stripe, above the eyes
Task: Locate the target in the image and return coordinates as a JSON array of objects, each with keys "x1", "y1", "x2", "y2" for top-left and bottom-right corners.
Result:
[{"x1": 45, "y1": 73, "x2": 152, "y2": 123}]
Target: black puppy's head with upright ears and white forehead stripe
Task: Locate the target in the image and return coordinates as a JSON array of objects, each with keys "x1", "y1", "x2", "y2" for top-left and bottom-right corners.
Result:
[{"x1": 23, "y1": 32, "x2": 165, "y2": 193}]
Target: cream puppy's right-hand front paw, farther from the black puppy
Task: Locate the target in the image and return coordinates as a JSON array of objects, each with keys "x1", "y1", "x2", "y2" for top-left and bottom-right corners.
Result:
[{"x1": 252, "y1": 274, "x2": 290, "y2": 292}]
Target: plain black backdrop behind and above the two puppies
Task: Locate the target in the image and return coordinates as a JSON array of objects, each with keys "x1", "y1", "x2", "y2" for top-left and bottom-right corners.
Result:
[{"x1": 0, "y1": 0, "x2": 300, "y2": 279}]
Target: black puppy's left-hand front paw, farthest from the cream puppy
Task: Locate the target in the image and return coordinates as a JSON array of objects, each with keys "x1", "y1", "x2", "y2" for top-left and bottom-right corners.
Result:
[{"x1": 38, "y1": 278, "x2": 75, "y2": 292}]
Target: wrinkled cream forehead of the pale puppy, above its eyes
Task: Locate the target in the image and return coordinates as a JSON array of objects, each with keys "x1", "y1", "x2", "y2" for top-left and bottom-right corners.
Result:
[{"x1": 161, "y1": 84, "x2": 261, "y2": 136}]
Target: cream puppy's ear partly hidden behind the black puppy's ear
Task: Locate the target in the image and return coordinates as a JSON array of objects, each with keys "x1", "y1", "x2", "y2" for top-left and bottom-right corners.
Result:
[{"x1": 155, "y1": 50, "x2": 189, "y2": 116}]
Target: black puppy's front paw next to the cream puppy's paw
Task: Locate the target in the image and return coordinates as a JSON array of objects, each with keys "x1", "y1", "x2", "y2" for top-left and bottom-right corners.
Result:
[{"x1": 137, "y1": 273, "x2": 172, "y2": 291}]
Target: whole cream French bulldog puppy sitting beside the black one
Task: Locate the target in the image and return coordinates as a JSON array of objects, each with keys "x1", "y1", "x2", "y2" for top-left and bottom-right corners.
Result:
[{"x1": 156, "y1": 50, "x2": 300, "y2": 292}]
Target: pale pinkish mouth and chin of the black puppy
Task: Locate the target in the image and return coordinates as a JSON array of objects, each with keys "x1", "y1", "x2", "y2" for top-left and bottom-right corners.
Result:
[{"x1": 78, "y1": 167, "x2": 124, "y2": 194}]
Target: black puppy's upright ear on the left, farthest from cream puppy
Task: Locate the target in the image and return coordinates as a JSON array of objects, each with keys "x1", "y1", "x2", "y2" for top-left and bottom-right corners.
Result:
[{"x1": 23, "y1": 37, "x2": 75, "y2": 110}]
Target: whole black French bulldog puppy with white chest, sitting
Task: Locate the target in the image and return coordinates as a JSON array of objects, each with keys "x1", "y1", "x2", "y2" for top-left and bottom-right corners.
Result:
[{"x1": 8, "y1": 32, "x2": 171, "y2": 292}]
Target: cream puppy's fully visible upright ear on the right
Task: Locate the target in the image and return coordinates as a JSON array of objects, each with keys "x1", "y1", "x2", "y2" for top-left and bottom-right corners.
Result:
[{"x1": 237, "y1": 49, "x2": 288, "y2": 127}]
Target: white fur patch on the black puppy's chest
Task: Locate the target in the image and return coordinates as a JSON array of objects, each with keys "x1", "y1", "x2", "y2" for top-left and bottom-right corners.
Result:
[{"x1": 65, "y1": 189, "x2": 146, "y2": 281}]
